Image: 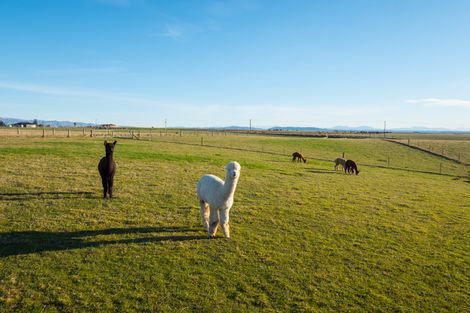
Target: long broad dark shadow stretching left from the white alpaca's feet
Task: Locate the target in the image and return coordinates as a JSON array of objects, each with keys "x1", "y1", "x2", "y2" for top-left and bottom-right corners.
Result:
[{"x1": 0, "y1": 227, "x2": 210, "y2": 258}]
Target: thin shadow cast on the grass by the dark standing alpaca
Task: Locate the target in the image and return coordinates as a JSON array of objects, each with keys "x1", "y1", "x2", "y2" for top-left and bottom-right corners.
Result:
[{"x1": 0, "y1": 191, "x2": 98, "y2": 201}]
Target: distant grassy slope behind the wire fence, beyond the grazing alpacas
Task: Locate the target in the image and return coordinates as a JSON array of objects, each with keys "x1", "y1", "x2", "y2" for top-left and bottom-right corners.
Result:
[{"x1": 154, "y1": 134, "x2": 470, "y2": 176}]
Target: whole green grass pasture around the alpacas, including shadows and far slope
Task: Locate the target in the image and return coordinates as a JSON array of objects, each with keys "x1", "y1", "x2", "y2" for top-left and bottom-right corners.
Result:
[{"x1": 0, "y1": 135, "x2": 470, "y2": 312}]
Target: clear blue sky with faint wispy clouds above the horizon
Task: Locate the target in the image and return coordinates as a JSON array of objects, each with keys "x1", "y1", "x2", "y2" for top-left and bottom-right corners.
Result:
[{"x1": 0, "y1": 0, "x2": 470, "y2": 128}]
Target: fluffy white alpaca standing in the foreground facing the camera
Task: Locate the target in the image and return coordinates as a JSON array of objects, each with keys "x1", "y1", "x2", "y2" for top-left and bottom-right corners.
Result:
[{"x1": 196, "y1": 161, "x2": 241, "y2": 238}]
